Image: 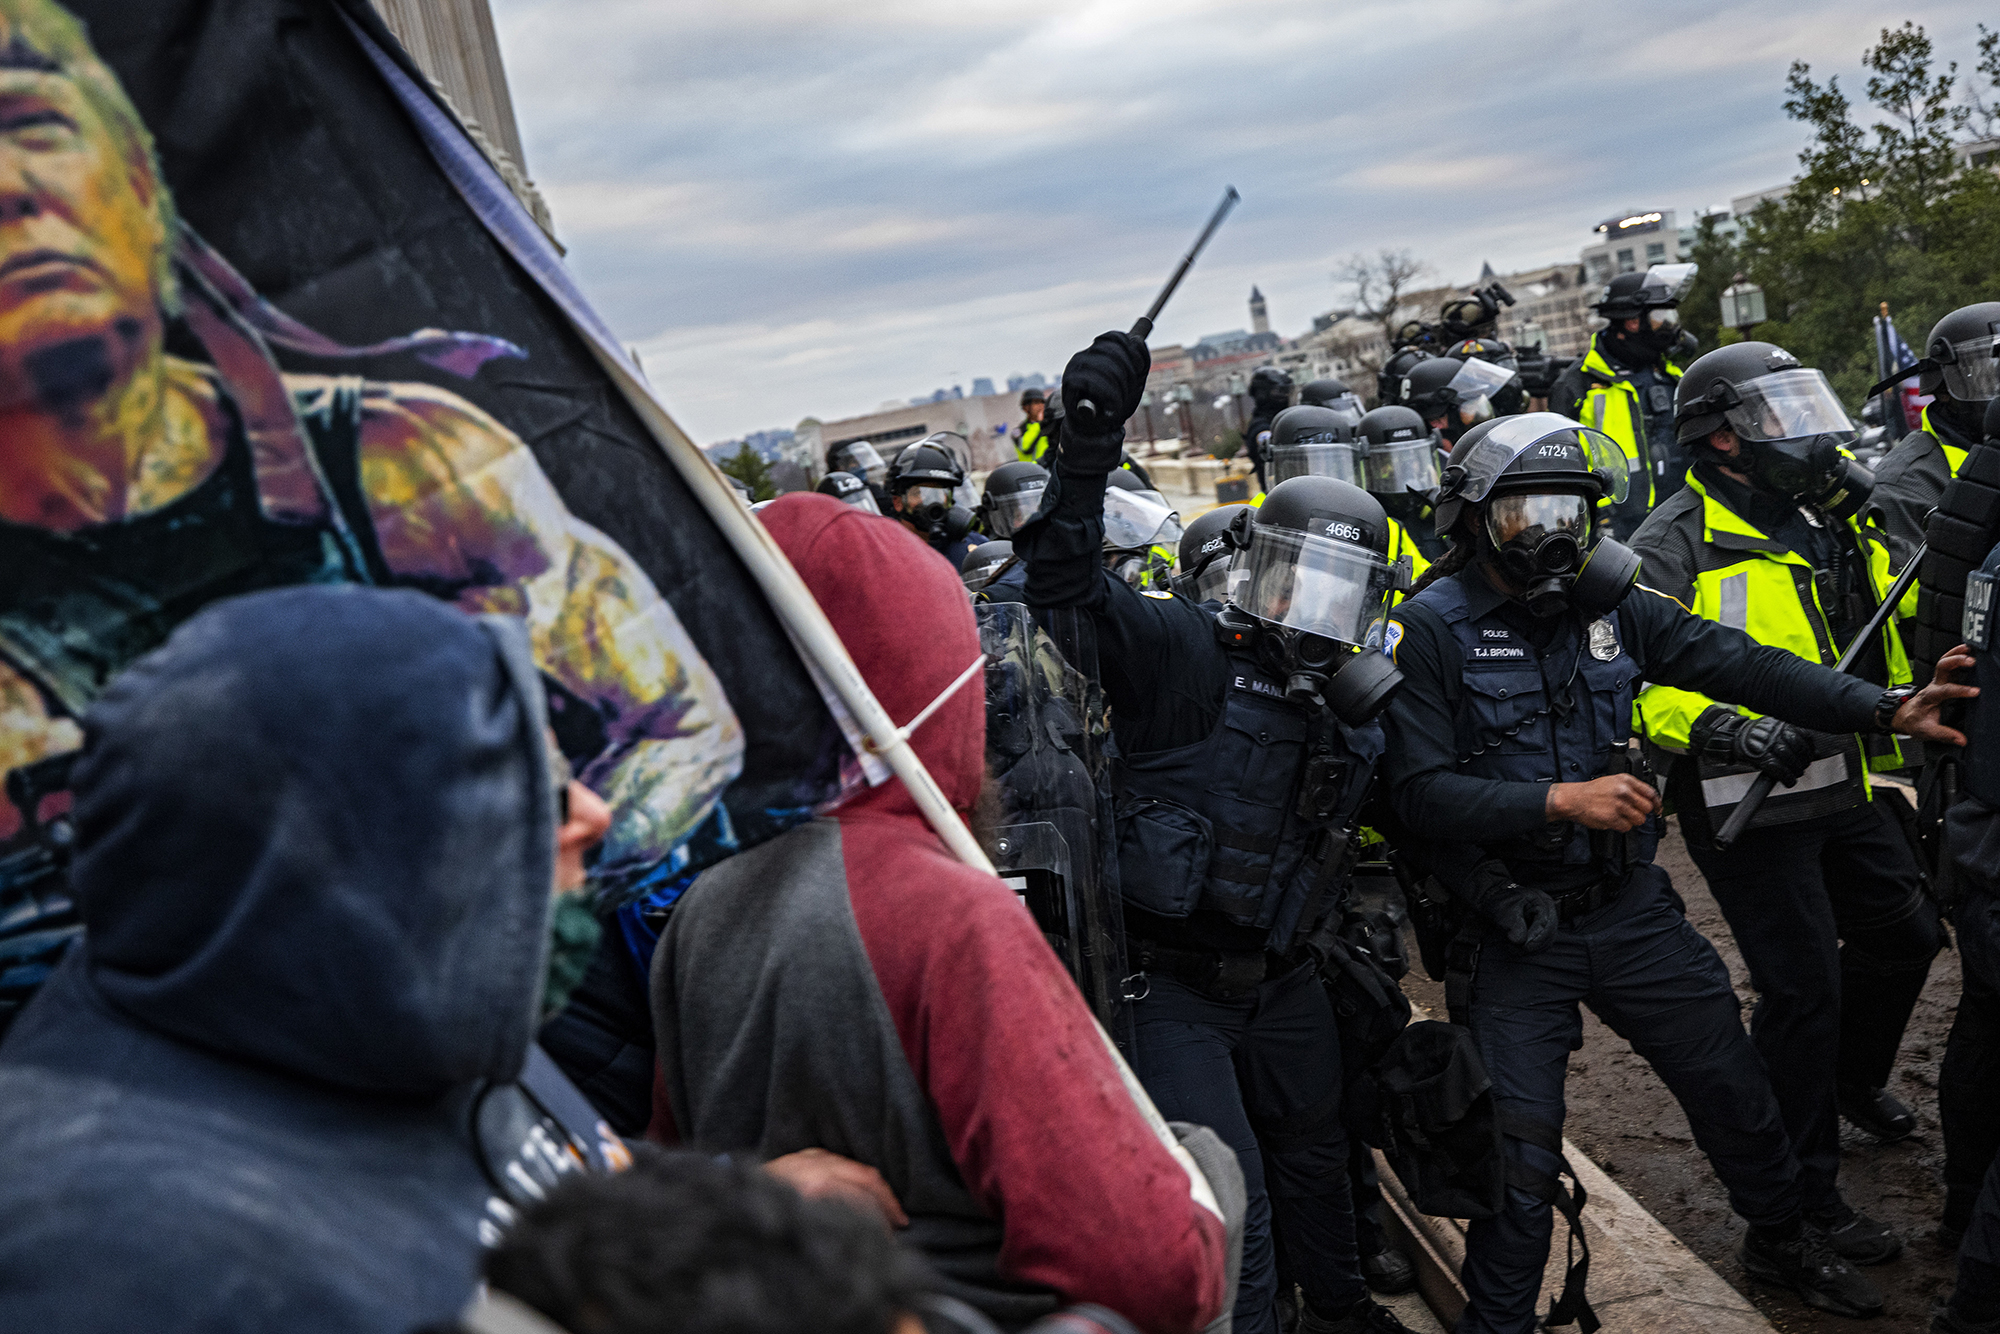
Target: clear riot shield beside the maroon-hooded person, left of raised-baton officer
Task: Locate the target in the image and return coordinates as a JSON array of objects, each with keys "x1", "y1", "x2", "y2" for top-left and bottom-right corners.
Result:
[{"x1": 976, "y1": 602, "x2": 1132, "y2": 1056}]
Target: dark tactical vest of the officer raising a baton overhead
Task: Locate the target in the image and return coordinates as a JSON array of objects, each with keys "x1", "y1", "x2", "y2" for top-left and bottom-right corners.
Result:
[{"x1": 1116, "y1": 636, "x2": 1384, "y2": 952}]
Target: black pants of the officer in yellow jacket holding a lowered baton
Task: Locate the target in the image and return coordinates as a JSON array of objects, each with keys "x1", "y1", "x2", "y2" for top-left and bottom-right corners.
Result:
[{"x1": 1688, "y1": 792, "x2": 1944, "y2": 1210}]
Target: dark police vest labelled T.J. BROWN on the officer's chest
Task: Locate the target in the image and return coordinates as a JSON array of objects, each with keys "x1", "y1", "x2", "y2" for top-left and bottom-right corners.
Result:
[{"x1": 1416, "y1": 574, "x2": 1660, "y2": 888}]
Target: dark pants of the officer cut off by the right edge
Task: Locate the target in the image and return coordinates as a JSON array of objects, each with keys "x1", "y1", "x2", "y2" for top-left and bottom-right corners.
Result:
[{"x1": 1938, "y1": 890, "x2": 2000, "y2": 1240}]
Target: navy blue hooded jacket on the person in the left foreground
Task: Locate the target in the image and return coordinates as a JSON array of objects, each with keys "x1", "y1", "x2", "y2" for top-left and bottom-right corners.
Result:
[{"x1": 0, "y1": 586, "x2": 560, "y2": 1334}]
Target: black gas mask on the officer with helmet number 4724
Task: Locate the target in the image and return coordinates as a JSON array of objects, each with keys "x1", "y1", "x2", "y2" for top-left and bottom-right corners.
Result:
[{"x1": 1484, "y1": 492, "x2": 1640, "y2": 616}]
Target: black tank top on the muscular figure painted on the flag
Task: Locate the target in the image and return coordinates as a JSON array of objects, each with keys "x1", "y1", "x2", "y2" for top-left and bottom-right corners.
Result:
[{"x1": 0, "y1": 380, "x2": 380, "y2": 718}]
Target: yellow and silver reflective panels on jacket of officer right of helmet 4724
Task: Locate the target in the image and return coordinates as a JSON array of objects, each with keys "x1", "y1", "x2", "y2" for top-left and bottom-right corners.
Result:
[{"x1": 1632, "y1": 470, "x2": 1910, "y2": 828}]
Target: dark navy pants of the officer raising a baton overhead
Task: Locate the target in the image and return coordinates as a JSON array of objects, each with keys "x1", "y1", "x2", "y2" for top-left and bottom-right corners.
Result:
[{"x1": 1132, "y1": 968, "x2": 1366, "y2": 1334}]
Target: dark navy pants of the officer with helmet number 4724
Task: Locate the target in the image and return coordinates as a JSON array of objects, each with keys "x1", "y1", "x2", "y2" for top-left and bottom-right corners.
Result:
[{"x1": 1458, "y1": 864, "x2": 1798, "y2": 1334}]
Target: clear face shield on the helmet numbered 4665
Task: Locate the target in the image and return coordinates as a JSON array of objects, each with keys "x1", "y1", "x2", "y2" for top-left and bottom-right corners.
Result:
[{"x1": 1230, "y1": 524, "x2": 1396, "y2": 646}]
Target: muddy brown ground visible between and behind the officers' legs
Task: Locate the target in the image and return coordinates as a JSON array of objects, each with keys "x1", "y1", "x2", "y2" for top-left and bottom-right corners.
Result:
[{"x1": 1404, "y1": 832, "x2": 1958, "y2": 1334}]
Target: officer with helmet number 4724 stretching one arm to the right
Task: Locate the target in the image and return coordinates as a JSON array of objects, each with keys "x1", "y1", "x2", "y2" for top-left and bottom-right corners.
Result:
[{"x1": 1384, "y1": 412, "x2": 1956, "y2": 1334}]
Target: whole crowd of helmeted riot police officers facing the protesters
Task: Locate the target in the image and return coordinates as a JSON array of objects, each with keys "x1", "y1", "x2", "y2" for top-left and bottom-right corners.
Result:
[{"x1": 820, "y1": 290, "x2": 2000, "y2": 1334}]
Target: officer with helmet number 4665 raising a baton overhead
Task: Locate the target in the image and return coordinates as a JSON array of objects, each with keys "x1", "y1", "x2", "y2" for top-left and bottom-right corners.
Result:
[{"x1": 1014, "y1": 334, "x2": 1400, "y2": 1334}]
